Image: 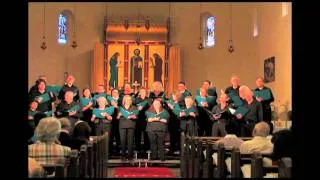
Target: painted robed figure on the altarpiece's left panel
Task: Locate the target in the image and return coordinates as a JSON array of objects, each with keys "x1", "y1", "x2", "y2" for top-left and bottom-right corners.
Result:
[{"x1": 109, "y1": 52, "x2": 120, "y2": 88}]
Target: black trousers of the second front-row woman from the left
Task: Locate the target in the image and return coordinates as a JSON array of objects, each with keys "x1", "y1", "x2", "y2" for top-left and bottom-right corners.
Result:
[{"x1": 119, "y1": 128, "x2": 134, "y2": 158}]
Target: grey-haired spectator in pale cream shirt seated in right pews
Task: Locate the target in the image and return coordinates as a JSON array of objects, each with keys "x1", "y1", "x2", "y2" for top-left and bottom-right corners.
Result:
[{"x1": 240, "y1": 122, "x2": 273, "y2": 154}]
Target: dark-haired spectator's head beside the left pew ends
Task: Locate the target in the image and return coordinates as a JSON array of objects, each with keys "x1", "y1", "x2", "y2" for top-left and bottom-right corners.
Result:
[{"x1": 71, "y1": 120, "x2": 91, "y2": 150}]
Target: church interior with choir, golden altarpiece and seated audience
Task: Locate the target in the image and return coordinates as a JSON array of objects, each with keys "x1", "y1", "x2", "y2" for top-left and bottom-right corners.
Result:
[{"x1": 28, "y1": 2, "x2": 292, "y2": 178}]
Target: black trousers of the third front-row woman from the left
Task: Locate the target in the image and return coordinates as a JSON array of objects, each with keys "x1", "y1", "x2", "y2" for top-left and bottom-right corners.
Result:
[{"x1": 148, "y1": 131, "x2": 166, "y2": 160}]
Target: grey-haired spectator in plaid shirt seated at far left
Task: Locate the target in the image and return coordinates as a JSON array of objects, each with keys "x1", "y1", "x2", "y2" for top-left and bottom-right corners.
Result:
[{"x1": 28, "y1": 117, "x2": 71, "y2": 165}]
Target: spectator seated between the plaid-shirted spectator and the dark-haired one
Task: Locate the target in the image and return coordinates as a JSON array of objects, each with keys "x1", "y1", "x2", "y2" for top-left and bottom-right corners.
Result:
[{"x1": 59, "y1": 118, "x2": 71, "y2": 147}]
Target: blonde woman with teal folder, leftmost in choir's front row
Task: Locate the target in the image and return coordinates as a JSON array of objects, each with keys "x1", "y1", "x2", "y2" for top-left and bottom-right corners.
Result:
[{"x1": 91, "y1": 97, "x2": 114, "y2": 136}]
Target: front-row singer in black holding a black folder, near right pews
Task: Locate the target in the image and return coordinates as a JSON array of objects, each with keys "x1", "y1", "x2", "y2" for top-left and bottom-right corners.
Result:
[{"x1": 211, "y1": 93, "x2": 236, "y2": 137}]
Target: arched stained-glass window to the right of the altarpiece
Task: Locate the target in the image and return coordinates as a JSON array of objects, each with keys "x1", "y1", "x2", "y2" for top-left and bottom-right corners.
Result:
[{"x1": 201, "y1": 13, "x2": 216, "y2": 48}]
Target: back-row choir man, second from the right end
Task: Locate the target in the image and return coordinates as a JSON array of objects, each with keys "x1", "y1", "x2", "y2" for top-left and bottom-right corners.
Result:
[{"x1": 225, "y1": 75, "x2": 243, "y2": 107}]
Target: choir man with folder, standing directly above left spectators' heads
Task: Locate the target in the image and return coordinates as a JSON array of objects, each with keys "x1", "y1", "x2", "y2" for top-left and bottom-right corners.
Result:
[{"x1": 56, "y1": 91, "x2": 82, "y2": 129}]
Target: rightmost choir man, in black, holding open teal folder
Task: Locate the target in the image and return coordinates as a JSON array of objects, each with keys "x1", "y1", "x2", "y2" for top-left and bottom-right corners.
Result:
[{"x1": 254, "y1": 77, "x2": 274, "y2": 133}]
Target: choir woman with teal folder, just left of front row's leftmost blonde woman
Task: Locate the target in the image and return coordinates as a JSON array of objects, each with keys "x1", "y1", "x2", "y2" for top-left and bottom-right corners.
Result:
[{"x1": 80, "y1": 88, "x2": 95, "y2": 135}]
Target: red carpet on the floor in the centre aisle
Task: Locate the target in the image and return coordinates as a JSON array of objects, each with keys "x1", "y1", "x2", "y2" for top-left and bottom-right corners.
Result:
[{"x1": 114, "y1": 167, "x2": 176, "y2": 178}]
